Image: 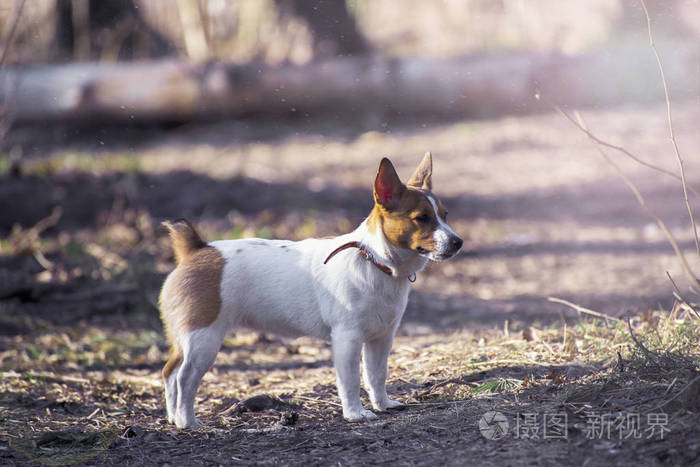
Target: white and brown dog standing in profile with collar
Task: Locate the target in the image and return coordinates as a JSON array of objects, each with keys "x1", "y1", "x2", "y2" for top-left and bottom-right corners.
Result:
[{"x1": 160, "y1": 153, "x2": 462, "y2": 428}]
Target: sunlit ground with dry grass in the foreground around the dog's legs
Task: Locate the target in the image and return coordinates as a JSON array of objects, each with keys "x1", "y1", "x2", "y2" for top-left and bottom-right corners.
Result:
[{"x1": 0, "y1": 305, "x2": 700, "y2": 465}]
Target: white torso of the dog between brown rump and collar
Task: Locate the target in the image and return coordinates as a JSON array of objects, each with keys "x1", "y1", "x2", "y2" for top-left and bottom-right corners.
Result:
[{"x1": 212, "y1": 239, "x2": 409, "y2": 339}]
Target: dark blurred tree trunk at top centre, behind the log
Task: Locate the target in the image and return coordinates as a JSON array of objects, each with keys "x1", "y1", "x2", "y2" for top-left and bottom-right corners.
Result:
[{"x1": 276, "y1": 0, "x2": 370, "y2": 59}]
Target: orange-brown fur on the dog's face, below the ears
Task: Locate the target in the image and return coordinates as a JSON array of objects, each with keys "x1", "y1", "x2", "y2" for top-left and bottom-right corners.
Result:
[{"x1": 367, "y1": 187, "x2": 445, "y2": 251}]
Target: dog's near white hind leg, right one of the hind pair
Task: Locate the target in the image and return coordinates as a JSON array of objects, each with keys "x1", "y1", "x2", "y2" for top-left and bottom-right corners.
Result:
[{"x1": 175, "y1": 327, "x2": 224, "y2": 428}]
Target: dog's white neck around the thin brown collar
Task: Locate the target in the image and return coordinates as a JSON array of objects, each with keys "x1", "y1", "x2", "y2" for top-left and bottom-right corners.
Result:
[{"x1": 351, "y1": 217, "x2": 428, "y2": 279}]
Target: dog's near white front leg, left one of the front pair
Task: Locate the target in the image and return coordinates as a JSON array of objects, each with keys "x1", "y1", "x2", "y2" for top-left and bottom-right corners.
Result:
[{"x1": 331, "y1": 329, "x2": 377, "y2": 422}]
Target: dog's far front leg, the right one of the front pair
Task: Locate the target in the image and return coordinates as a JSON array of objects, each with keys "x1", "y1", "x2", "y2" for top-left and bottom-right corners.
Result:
[{"x1": 362, "y1": 332, "x2": 403, "y2": 411}]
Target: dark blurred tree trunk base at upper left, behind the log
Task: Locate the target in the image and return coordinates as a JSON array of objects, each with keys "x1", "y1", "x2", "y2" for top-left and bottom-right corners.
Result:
[{"x1": 55, "y1": 0, "x2": 174, "y2": 61}]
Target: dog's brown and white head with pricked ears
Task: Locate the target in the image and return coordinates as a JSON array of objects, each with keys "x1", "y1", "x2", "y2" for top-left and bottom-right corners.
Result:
[{"x1": 370, "y1": 153, "x2": 462, "y2": 261}]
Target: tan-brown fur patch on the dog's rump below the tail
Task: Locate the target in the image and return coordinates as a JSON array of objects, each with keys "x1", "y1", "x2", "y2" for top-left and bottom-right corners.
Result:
[{"x1": 160, "y1": 246, "x2": 226, "y2": 344}]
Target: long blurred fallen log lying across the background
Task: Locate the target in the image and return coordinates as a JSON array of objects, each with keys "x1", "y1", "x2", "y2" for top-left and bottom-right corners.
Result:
[{"x1": 0, "y1": 44, "x2": 700, "y2": 123}]
